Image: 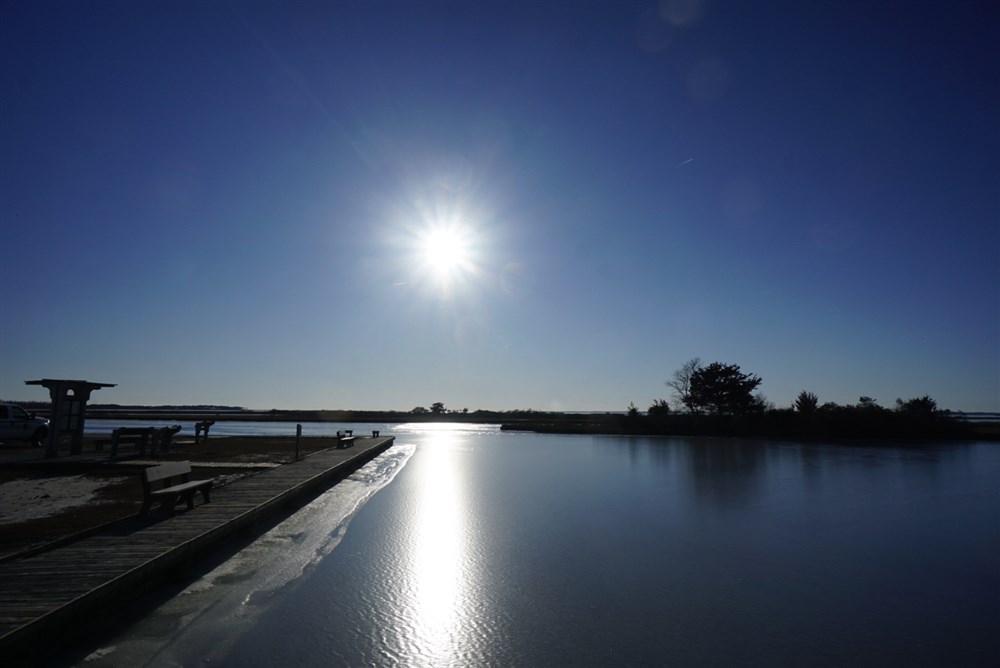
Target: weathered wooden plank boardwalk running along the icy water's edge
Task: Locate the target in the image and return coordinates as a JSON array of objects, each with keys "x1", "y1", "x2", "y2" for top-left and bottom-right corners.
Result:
[{"x1": 0, "y1": 436, "x2": 393, "y2": 665}]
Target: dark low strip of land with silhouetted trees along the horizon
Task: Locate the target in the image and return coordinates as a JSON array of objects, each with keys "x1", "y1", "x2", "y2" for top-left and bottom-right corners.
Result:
[{"x1": 5, "y1": 357, "x2": 1000, "y2": 441}]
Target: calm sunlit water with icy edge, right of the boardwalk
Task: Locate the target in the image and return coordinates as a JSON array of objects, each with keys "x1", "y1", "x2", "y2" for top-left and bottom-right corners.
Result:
[{"x1": 72, "y1": 425, "x2": 1000, "y2": 666}]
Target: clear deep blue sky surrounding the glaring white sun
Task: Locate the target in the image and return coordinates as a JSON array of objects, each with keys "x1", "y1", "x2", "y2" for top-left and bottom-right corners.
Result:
[{"x1": 0, "y1": 1, "x2": 1000, "y2": 410}]
